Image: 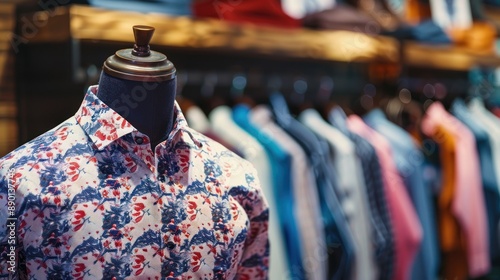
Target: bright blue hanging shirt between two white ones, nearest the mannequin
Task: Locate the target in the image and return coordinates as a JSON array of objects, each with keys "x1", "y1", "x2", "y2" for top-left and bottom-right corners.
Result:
[{"x1": 233, "y1": 105, "x2": 305, "y2": 279}]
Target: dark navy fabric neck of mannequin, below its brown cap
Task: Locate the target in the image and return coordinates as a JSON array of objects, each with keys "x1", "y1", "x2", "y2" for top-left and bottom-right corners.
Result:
[{"x1": 97, "y1": 72, "x2": 176, "y2": 149}]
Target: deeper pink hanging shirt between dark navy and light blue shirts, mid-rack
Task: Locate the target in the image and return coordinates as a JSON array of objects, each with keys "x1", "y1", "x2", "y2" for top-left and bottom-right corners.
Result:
[{"x1": 347, "y1": 115, "x2": 422, "y2": 280}]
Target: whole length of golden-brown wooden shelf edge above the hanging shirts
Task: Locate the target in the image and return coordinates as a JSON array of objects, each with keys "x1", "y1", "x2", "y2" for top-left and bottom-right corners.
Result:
[{"x1": 18, "y1": 5, "x2": 500, "y2": 71}]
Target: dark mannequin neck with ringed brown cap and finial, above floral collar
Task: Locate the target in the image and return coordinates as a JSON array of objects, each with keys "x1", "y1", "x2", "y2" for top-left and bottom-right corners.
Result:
[{"x1": 97, "y1": 25, "x2": 176, "y2": 149}]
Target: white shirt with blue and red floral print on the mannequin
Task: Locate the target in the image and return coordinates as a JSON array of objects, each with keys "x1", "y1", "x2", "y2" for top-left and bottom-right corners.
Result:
[{"x1": 0, "y1": 86, "x2": 269, "y2": 280}]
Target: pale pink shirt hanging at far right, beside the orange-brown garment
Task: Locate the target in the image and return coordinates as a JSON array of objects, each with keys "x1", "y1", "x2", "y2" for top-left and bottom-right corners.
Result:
[{"x1": 422, "y1": 102, "x2": 490, "y2": 277}]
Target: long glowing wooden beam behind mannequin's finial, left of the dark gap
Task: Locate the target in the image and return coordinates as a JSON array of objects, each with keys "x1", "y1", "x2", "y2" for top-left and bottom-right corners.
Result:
[{"x1": 70, "y1": 6, "x2": 398, "y2": 62}]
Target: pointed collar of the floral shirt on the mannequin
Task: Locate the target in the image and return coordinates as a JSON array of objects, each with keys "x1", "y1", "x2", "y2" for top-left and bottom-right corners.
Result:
[{"x1": 75, "y1": 85, "x2": 195, "y2": 150}]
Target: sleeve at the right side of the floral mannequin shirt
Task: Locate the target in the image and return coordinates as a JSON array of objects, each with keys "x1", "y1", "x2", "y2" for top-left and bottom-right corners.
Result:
[{"x1": 235, "y1": 164, "x2": 269, "y2": 280}]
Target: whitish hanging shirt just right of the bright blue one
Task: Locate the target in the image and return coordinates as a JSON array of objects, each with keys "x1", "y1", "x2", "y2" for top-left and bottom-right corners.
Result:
[{"x1": 250, "y1": 105, "x2": 326, "y2": 280}]
